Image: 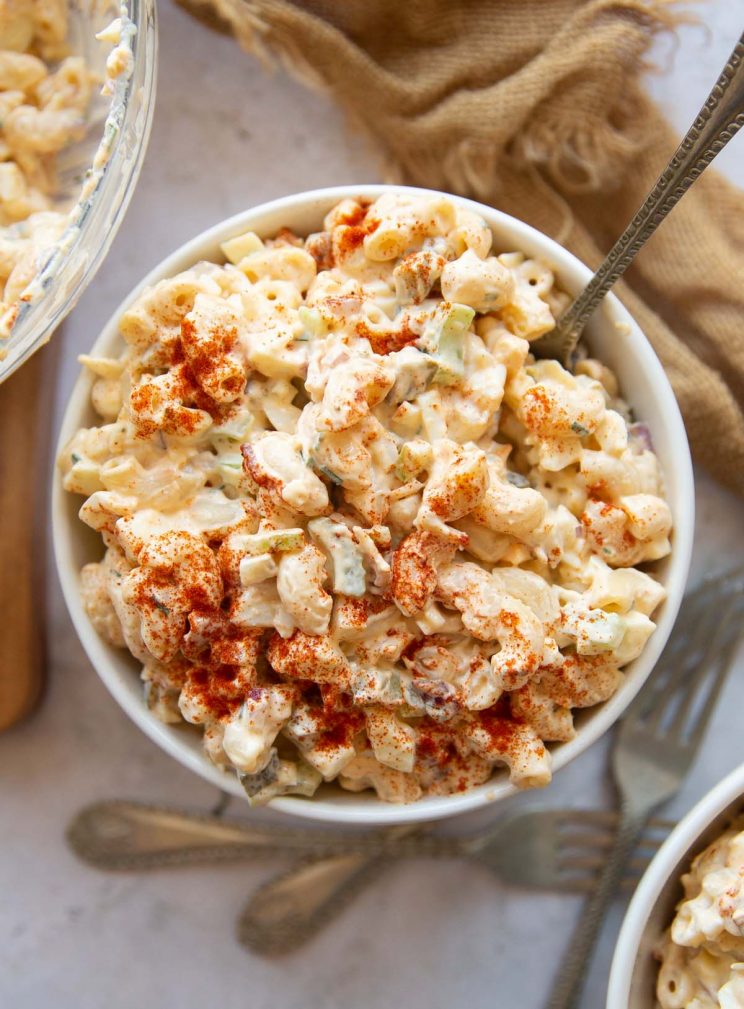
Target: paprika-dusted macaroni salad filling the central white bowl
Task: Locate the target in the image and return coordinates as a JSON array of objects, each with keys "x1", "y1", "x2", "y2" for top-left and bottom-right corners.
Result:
[{"x1": 60, "y1": 191, "x2": 671, "y2": 802}]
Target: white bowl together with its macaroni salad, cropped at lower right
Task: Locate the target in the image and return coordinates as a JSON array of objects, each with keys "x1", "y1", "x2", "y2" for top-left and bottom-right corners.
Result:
[{"x1": 607, "y1": 765, "x2": 744, "y2": 1009}]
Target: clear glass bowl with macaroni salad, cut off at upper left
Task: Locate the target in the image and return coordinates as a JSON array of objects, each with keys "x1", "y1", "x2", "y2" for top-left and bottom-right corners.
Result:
[{"x1": 0, "y1": 0, "x2": 156, "y2": 380}]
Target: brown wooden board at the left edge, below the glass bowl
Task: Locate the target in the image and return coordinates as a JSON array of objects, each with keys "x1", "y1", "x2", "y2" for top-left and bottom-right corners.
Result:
[{"x1": 0, "y1": 347, "x2": 53, "y2": 732}]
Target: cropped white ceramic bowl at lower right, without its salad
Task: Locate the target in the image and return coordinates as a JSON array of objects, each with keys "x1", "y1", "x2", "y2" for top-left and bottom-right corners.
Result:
[{"x1": 607, "y1": 764, "x2": 744, "y2": 1009}]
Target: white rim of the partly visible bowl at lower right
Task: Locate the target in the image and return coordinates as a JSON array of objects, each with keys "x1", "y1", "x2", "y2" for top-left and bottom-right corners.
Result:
[{"x1": 607, "y1": 764, "x2": 744, "y2": 1009}]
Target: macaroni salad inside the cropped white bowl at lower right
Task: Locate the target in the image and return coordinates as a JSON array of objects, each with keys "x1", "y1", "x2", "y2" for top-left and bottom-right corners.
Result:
[{"x1": 656, "y1": 817, "x2": 744, "y2": 1009}]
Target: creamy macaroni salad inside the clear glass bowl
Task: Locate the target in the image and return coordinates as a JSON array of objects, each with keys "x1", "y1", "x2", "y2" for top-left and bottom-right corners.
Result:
[{"x1": 0, "y1": 0, "x2": 131, "y2": 341}]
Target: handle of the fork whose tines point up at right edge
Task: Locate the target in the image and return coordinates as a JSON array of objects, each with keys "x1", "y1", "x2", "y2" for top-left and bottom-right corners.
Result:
[{"x1": 546, "y1": 802, "x2": 651, "y2": 1009}]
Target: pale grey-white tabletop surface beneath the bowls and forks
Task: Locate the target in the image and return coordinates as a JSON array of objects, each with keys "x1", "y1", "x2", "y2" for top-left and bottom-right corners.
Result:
[{"x1": 0, "y1": 0, "x2": 744, "y2": 1009}]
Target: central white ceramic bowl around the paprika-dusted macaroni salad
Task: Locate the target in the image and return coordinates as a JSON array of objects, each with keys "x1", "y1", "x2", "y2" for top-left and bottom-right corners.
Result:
[{"x1": 52, "y1": 186, "x2": 695, "y2": 824}]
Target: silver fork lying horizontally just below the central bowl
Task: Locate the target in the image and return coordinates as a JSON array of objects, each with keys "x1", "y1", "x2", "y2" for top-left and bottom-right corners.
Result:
[{"x1": 67, "y1": 800, "x2": 673, "y2": 893}]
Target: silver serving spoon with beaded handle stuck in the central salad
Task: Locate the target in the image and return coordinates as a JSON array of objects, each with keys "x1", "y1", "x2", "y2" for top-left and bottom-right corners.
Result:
[{"x1": 530, "y1": 34, "x2": 744, "y2": 366}]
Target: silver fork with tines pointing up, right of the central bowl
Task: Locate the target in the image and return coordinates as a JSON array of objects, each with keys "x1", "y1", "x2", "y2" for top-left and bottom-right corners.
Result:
[{"x1": 547, "y1": 569, "x2": 744, "y2": 1009}]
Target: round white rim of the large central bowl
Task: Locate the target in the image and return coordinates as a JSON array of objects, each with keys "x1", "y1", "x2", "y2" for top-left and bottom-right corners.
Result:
[{"x1": 51, "y1": 184, "x2": 695, "y2": 825}]
